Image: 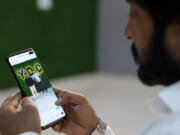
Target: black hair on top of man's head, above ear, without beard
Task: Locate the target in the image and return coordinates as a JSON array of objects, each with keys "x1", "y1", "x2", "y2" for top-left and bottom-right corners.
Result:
[{"x1": 127, "y1": 0, "x2": 180, "y2": 26}]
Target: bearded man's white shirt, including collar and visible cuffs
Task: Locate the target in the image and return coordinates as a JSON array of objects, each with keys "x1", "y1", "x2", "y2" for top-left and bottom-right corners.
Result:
[{"x1": 21, "y1": 82, "x2": 180, "y2": 135}]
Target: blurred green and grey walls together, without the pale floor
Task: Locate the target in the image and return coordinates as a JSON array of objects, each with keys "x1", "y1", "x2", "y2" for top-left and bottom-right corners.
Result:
[{"x1": 0, "y1": 0, "x2": 136, "y2": 88}]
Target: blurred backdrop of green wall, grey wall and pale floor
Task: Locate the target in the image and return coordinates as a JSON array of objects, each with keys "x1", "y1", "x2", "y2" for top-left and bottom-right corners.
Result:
[{"x1": 0, "y1": 0, "x2": 165, "y2": 135}]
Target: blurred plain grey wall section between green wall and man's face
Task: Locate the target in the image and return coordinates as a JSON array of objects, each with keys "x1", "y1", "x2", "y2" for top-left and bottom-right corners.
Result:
[{"x1": 97, "y1": 0, "x2": 136, "y2": 74}]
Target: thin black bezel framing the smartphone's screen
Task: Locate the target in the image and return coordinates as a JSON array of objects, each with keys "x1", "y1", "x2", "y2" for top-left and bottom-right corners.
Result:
[{"x1": 5, "y1": 48, "x2": 66, "y2": 130}]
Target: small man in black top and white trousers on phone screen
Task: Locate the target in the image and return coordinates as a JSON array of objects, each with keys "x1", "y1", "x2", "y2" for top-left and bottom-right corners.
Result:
[{"x1": 25, "y1": 73, "x2": 38, "y2": 98}]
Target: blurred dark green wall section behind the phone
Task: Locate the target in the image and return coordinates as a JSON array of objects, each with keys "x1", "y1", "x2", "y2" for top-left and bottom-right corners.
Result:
[{"x1": 0, "y1": 0, "x2": 97, "y2": 88}]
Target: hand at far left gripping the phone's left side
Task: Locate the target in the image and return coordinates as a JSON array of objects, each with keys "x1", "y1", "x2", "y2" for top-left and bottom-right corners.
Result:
[{"x1": 0, "y1": 93, "x2": 41, "y2": 135}]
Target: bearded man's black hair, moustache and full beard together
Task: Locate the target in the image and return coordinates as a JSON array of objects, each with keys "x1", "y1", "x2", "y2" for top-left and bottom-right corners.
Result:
[{"x1": 127, "y1": 0, "x2": 180, "y2": 85}]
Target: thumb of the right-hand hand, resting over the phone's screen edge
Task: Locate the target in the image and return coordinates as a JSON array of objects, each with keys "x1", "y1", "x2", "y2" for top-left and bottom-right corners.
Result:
[{"x1": 56, "y1": 91, "x2": 86, "y2": 105}]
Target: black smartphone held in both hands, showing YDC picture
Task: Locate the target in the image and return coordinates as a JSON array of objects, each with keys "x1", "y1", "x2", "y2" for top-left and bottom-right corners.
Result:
[{"x1": 6, "y1": 48, "x2": 66, "y2": 129}]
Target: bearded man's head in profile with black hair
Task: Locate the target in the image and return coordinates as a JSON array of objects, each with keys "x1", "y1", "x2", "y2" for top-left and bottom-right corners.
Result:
[{"x1": 125, "y1": 0, "x2": 180, "y2": 85}]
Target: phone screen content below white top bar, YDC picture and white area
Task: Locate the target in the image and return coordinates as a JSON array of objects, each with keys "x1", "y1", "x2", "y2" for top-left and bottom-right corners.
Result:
[{"x1": 12, "y1": 52, "x2": 65, "y2": 126}]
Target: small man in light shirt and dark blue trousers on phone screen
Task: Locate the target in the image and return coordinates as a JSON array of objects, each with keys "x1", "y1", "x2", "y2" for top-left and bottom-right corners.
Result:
[{"x1": 32, "y1": 71, "x2": 48, "y2": 92}]
